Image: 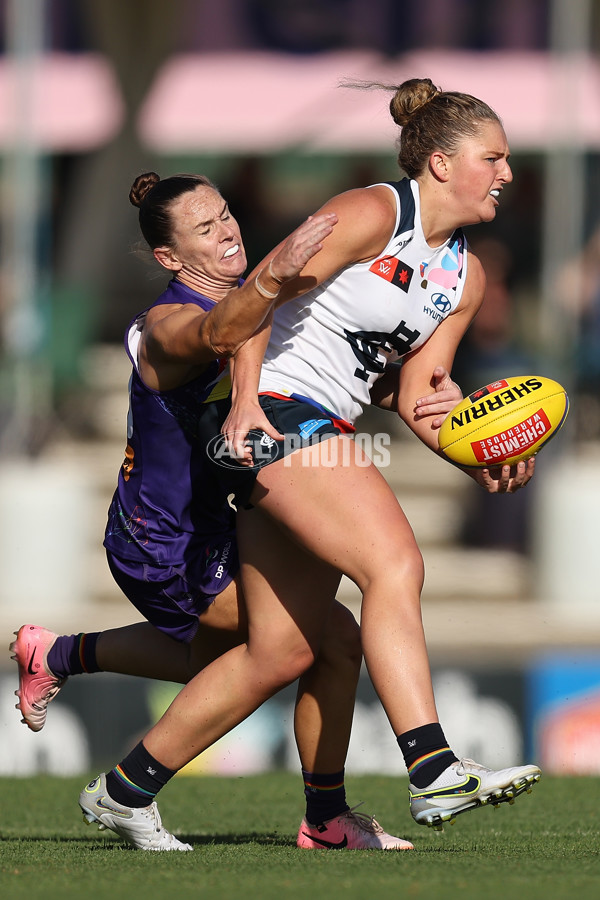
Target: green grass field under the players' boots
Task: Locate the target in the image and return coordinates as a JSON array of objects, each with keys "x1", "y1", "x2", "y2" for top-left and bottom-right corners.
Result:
[{"x1": 0, "y1": 773, "x2": 600, "y2": 900}]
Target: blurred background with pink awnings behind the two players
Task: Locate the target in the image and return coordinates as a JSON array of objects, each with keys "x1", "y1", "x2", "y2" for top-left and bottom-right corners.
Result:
[{"x1": 0, "y1": 0, "x2": 600, "y2": 773}]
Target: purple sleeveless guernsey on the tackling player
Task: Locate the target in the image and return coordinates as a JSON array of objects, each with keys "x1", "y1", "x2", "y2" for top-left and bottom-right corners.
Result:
[{"x1": 104, "y1": 280, "x2": 235, "y2": 566}]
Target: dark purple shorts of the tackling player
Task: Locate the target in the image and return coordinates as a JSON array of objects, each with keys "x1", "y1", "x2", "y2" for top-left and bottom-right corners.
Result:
[{"x1": 106, "y1": 531, "x2": 239, "y2": 644}]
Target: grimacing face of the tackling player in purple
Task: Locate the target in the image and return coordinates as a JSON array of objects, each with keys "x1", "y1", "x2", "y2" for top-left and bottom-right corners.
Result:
[{"x1": 171, "y1": 185, "x2": 247, "y2": 283}]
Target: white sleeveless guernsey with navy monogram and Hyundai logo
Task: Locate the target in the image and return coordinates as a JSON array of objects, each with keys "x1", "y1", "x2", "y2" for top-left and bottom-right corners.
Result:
[{"x1": 259, "y1": 178, "x2": 467, "y2": 423}]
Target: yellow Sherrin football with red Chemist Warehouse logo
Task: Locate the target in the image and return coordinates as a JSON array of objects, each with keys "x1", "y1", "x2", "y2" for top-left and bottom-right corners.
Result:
[{"x1": 438, "y1": 375, "x2": 569, "y2": 468}]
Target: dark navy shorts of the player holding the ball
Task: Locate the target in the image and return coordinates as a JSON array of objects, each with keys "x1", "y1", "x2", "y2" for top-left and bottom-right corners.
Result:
[{"x1": 203, "y1": 394, "x2": 353, "y2": 509}]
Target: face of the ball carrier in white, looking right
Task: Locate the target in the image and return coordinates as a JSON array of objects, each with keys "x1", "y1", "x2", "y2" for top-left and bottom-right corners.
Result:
[{"x1": 449, "y1": 122, "x2": 512, "y2": 225}]
